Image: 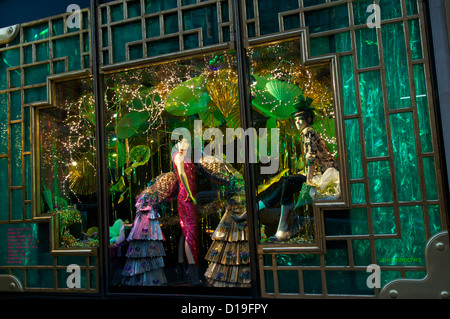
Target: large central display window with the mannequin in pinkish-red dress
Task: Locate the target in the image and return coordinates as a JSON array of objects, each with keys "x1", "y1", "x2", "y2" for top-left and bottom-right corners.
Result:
[{"x1": 105, "y1": 53, "x2": 251, "y2": 289}]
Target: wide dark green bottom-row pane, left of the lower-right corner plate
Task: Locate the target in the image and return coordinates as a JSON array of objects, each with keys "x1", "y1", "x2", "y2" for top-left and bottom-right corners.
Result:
[{"x1": 325, "y1": 270, "x2": 374, "y2": 295}]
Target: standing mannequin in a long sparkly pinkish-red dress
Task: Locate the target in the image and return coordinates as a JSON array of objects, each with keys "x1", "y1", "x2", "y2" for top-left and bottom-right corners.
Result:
[{"x1": 172, "y1": 139, "x2": 200, "y2": 285}]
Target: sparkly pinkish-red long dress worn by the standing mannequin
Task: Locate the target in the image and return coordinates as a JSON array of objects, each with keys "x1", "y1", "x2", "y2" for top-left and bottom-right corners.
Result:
[{"x1": 172, "y1": 152, "x2": 199, "y2": 265}]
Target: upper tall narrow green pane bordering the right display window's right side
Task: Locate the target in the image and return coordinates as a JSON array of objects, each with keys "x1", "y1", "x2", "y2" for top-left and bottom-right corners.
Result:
[{"x1": 339, "y1": 55, "x2": 358, "y2": 115}]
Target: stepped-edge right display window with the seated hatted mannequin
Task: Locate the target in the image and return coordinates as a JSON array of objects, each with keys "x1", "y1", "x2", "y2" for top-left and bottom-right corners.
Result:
[{"x1": 248, "y1": 40, "x2": 341, "y2": 247}]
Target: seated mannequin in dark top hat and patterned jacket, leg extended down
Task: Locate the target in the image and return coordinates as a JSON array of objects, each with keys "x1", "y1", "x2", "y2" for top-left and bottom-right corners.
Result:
[{"x1": 233, "y1": 98, "x2": 337, "y2": 241}]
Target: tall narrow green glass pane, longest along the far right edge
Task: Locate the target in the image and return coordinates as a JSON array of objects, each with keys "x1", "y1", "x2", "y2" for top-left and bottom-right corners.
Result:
[{"x1": 413, "y1": 64, "x2": 433, "y2": 153}]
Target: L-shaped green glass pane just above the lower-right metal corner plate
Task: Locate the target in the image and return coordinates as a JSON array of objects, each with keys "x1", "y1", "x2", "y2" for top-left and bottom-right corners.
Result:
[{"x1": 375, "y1": 206, "x2": 426, "y2": 266}]
